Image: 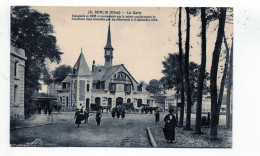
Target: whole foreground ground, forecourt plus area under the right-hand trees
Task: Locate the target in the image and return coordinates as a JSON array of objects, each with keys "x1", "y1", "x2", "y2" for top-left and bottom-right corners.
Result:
[{"x1": 10, "y1": 112, "x2": 231, "y2": 147}]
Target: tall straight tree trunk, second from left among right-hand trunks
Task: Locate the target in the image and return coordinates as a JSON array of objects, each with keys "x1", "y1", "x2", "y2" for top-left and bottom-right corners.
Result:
[{"x1": 185, "y1": 7, "x2": 191, "y2": 129}]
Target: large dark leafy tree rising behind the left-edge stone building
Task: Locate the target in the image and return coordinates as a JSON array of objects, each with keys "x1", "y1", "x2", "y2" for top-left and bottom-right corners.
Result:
[{"x1": 11, "y1": 6, "x2": 62, "y2": 116}]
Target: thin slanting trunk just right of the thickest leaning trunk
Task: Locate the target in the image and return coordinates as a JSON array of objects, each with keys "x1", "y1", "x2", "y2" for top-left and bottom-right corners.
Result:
[{"x1": 217, "y1": 34, "x2": 229, "y2": 125}]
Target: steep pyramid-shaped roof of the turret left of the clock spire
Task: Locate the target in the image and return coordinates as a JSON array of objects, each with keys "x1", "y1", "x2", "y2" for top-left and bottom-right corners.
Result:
[{"x1": 73, "y1": 48, "x2": 91, "y2": 75}]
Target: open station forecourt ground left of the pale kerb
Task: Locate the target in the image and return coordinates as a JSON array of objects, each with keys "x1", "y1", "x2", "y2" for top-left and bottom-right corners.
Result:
[{"x1": 10, "y1": 112, "x2": 151, "y2": 147}]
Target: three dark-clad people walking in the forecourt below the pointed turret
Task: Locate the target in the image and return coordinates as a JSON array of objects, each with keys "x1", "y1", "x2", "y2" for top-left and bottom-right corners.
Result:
[{"x1": 74, "y1": 107, "x2": 102, "y2": 127}]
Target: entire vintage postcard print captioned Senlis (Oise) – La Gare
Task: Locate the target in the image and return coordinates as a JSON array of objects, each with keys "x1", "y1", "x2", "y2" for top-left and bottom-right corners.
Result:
[{"x1": 10, "y1": 5, "x2": 234, "y2": 149}]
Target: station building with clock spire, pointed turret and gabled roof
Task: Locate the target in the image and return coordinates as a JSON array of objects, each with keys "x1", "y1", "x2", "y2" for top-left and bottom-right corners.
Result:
[{"x1": 58, "y1": 23, "x2": 151, "y2": 111}]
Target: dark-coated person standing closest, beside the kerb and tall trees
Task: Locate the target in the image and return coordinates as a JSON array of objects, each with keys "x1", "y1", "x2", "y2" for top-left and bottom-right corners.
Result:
[{"x1": 164, "y1": 109, "x2": 177, "y2": 143}]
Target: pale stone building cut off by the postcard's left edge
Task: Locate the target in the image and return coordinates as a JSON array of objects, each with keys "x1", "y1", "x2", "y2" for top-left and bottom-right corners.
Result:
[{"x1": 10, "y1": 43, "x2": 26, "y2": 120}]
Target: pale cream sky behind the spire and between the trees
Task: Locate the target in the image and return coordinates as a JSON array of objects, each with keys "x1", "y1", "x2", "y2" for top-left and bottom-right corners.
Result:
[{"x1": 32, "y1": 7, "x2": 233, "y2": 91}]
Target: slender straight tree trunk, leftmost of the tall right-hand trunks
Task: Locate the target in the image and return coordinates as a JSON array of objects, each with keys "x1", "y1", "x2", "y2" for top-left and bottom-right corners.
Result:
[{"x1": 178, "y1": 7, "x2": 185, "y2": 127}]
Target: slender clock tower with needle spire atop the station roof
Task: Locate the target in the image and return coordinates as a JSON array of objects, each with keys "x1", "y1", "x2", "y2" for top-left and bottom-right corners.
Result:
[{"x1": 104, "y1": 21, "x2": 114, "y2": 67}]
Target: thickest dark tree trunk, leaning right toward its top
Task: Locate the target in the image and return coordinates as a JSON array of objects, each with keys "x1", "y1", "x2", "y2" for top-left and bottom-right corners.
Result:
[{"x1": 210, "y1": 8, "x2": 227, "y2": 139}]
